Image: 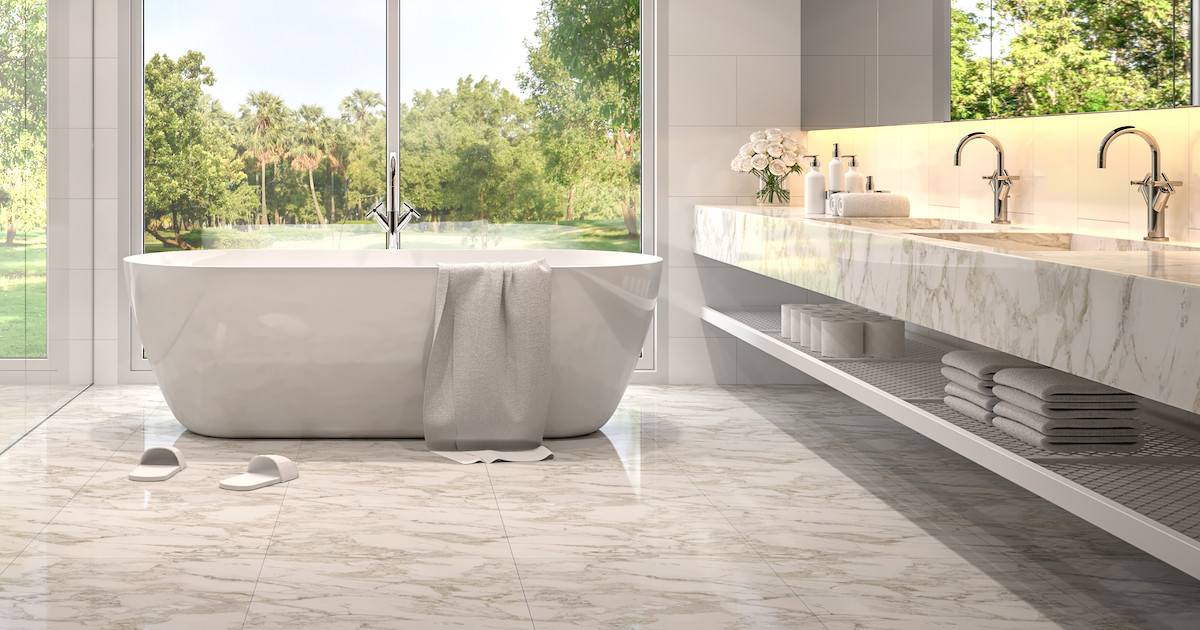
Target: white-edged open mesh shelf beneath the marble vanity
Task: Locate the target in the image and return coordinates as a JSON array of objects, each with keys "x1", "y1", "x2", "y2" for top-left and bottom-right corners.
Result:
[{"x1": 701, "y1": 306, "x2": 1200, "y2": 578}]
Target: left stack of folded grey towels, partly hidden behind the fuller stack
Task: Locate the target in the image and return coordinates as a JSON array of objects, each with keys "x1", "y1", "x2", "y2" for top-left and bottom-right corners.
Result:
[{"x1": 942, "y1": 350, "x2": 1039, "y2": 424}]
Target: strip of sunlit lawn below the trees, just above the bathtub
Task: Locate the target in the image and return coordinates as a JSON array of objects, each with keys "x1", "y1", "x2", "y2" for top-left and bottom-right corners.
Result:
[{"x1": 145, "y1": 218, "x2": 642, "y2": 252}]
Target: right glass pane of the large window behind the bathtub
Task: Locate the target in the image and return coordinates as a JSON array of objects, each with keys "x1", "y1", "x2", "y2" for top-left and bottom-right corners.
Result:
[{"x1": 397, "y1": 0, "x2": 641, "y2": 252}]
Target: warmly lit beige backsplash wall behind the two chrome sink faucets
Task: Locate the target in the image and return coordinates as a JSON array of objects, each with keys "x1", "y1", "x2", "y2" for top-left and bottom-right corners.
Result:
[{"x1": 808, "y1": 108, "x2": 1200, "y2": 241}]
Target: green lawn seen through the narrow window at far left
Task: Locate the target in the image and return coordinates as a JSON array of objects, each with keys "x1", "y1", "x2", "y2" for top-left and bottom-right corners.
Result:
[{"x1": 0, "y1": 232, "x2": 46, "y2": 358}]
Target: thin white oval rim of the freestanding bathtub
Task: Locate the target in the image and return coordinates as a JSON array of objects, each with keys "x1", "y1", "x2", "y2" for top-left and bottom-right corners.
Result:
[{"x1": 122, "y1": 250, "x2": 664, "y2": 270}]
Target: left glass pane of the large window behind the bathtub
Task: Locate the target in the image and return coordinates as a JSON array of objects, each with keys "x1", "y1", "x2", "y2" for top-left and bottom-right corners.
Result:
[{"x1": 143, "y1": 0, "x2": 386, "y2": 252}]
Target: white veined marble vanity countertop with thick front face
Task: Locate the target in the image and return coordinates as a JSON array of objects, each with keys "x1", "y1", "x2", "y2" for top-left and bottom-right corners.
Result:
[{"x1": 694, "y1": 205, "x2": 1200, "y2": 413}]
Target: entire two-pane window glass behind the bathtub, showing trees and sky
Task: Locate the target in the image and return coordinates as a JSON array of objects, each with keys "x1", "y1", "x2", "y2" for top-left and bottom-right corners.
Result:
[{"x1": 143, "y1": 0, "x2": 641, "y2": 251}]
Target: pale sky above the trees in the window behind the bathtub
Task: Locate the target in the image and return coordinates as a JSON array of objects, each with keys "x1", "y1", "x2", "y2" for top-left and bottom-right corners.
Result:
[{"x1": 144, "y1": 0, "x2": 540, "y2": 114}]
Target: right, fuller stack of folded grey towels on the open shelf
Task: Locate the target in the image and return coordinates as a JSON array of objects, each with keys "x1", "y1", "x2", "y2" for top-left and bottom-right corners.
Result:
[{"x1": 992, "y1": 367, "x2": 1142, "y2": 452}]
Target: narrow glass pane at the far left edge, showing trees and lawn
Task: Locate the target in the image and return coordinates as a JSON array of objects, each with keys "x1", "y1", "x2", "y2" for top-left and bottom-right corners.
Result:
[{"x1": 0, "y1": 0, "x2": 47, "y2": 358}]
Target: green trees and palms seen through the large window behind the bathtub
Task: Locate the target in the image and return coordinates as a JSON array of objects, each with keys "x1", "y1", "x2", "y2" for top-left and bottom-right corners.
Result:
[{"x1": 144, "y1": 0, "x2": 641, "y2": 251}]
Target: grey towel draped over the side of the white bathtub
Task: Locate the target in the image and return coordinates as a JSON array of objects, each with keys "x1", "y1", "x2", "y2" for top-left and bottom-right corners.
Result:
[{"x1": 424, "y1": 259, "x2": 553, "y2": 463}]
